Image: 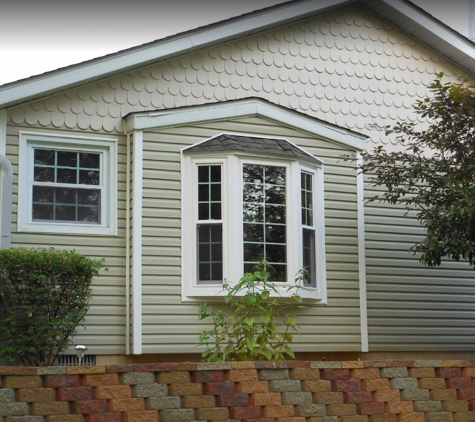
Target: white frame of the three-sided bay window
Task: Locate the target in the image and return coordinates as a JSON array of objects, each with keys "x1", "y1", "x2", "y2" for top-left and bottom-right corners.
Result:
[{"x1": 182, "y1": 150, "x2": 327, "y2": 303}]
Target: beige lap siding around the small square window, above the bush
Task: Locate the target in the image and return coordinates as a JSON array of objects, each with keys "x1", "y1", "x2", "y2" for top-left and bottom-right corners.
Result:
[{"x1": 7, "y1": 126, "x2": 127, "y2": 354}]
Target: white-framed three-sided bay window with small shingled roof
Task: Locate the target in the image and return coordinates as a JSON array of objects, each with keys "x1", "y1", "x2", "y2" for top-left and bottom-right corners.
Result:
[{"x1": 182, "y1": 134, "x2": 326, "y2": 301}]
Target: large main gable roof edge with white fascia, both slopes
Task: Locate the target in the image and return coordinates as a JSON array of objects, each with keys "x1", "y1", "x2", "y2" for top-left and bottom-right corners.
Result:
[{"x1": 0, "y1": 0, "x2": 475, "y2": 109}]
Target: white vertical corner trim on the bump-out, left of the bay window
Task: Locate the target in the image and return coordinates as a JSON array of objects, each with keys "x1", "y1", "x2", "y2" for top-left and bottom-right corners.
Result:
[{"x1": 132, "y1": 130, "x2": 143, "y2": 355}]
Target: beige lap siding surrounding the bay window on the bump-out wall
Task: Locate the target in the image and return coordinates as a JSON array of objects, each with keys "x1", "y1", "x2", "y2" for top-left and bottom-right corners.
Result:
[{"x1": 142, "y1": 118, "x2": 360, "y2": 353}]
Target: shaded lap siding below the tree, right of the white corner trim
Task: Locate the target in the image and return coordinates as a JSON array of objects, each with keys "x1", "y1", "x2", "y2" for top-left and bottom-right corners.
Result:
[{"x1": 365, "y1": 187, "x2": 475, "y2": 351}]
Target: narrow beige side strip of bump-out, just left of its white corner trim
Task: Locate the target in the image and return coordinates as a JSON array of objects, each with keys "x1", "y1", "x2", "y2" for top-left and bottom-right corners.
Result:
[{"x1": 125, "y1": 133, "x2": 132, "y2": 355}]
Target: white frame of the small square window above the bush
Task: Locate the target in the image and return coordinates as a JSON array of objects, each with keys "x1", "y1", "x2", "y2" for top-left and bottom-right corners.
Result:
[{"x1": 17, "y1": 132, "x2": 118, "y2": 236}]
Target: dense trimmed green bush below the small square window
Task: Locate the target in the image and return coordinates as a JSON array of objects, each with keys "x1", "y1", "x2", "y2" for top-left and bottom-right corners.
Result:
[{"x1": 0, "y1": 248, "x2": 104, "y2": 366}]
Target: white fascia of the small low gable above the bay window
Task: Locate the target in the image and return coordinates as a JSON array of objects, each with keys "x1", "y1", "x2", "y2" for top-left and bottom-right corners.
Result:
[{"x1": 126, "y1": 100, "x2": 366, "y2": 151}]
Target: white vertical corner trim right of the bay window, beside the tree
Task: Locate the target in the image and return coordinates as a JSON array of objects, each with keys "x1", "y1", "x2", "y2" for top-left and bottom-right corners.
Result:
[{"x1": 356, "y1": 152, "x2": 369, "y2": 352}]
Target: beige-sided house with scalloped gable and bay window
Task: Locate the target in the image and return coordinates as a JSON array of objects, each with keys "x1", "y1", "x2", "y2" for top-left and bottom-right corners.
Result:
[{"x1": 0, "y1": 0, "x2": 475, "y2": 361}]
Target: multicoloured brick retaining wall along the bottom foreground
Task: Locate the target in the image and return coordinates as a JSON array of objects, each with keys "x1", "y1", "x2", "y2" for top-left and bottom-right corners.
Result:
[{"x1": 0, "y1": 360, "x2": 475, "y2": 422}]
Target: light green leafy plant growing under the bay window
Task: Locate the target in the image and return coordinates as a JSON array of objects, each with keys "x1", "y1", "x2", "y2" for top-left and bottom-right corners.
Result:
[{"x1": 199, "y1": 261, "x2": 305, "y2": 362}]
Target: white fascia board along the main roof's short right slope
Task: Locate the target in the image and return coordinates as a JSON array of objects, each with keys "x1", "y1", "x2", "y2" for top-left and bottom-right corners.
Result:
[{"x1": 381, "y1": 0, "x2": 475, "y2": 59}]
